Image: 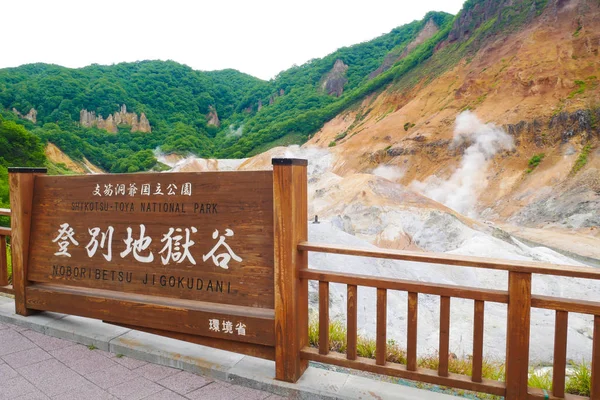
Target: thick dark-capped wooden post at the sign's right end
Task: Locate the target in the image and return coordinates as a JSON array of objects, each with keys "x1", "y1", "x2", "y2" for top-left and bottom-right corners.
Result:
[{"x1": 273, "y1": 158, "x2": 308, "y2": 382}]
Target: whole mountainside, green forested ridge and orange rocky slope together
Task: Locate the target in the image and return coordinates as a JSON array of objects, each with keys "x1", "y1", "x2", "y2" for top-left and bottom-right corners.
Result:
[{"x1": 0, "y1": 0, "x2": 600, "y2": 250}]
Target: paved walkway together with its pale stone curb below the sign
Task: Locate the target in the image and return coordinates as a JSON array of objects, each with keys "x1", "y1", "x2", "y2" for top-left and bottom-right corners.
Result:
[{"x1": 0, "y1": 297, "x2": 456, "y2": 400}]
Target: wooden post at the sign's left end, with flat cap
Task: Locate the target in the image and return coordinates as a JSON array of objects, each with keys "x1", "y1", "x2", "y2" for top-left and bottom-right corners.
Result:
[{"x1": 8, "y1": 168, "x2": 46, "y2": 315}]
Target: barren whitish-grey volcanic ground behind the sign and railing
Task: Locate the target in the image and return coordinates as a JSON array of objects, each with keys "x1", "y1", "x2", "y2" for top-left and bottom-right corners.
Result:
[{"x1": 162, "y1": 146, "x2": 600, "y2": 364}]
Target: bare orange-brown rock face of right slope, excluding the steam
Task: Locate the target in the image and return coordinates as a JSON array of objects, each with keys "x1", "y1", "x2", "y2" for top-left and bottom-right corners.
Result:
[{"x1": 306, "y1": 0, "x2": 600, "y2": 235}]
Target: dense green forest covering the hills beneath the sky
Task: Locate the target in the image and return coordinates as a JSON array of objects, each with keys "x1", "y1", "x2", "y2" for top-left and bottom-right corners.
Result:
[{"x1": 0, "y1": 0, "x2": 547, "y2": 209}]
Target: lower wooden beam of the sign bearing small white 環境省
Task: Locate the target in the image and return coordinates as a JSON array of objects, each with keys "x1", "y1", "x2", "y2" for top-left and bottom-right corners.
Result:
[{"x1": 26, "y1": 283, "x2": 275, "y2": 346}]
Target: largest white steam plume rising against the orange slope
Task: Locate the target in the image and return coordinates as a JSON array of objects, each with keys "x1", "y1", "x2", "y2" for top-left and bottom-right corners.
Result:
[{"x1": 411, "y1": 111, "x2": 514, "y2": 216}]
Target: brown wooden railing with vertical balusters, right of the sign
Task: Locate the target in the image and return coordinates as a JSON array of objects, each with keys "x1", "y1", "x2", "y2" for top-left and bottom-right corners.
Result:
[{"x1": 298, "y1": 242, "x2": 600, "y2": 400}]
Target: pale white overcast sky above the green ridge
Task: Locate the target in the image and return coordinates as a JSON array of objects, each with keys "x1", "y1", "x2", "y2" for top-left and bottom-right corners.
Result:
[{"x1": 0, "y1": 0, "x2": 465, "y2": 79}]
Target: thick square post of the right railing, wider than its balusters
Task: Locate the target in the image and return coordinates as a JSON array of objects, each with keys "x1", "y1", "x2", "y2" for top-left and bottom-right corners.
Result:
[{"x1": 505, "y1": 272, "x2": 531, "y2": 400}]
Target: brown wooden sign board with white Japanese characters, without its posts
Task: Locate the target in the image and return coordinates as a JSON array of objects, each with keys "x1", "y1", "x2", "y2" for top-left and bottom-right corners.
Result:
[{"x1": 17, "y1": 171, "x2": 274, "y2": 345}]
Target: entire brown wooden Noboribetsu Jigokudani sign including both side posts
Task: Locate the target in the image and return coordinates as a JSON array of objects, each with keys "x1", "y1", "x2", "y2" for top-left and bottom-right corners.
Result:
[{"x1": 9, "y1": 159, "x2": 308, "y2": 382}]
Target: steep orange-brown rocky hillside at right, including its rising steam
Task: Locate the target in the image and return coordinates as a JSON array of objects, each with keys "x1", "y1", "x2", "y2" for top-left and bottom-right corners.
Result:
[{"x1": 308, "y1": 0, "x2": 600, "y2": 247}]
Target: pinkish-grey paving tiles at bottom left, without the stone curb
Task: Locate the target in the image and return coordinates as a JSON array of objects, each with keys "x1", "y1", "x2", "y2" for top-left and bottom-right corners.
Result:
[{"x1": 0, "y1": 323, "x2": 283, "y2": 400}]
